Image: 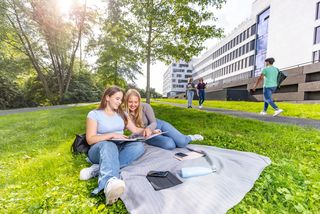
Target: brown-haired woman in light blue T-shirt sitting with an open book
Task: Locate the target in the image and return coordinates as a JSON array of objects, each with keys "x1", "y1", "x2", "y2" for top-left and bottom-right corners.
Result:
[{"x1": 85, "y1": 86, "x2": 144, "y2": 204}]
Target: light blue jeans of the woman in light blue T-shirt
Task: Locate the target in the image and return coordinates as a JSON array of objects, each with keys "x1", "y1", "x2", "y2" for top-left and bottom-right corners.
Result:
[{"x1": 88, "y1": 141, "x2": 144, "y2": 194}]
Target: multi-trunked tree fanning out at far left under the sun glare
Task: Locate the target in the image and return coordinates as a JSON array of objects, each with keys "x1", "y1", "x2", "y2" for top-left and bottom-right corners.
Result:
[{"x1": 0, "y1": 0, "x2": 86, "y2": 103}]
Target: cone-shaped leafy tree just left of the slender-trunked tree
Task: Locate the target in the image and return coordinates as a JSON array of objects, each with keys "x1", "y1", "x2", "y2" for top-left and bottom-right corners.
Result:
[{"x1": 98, "y1": 0, "x2": 142, "y2": 87}]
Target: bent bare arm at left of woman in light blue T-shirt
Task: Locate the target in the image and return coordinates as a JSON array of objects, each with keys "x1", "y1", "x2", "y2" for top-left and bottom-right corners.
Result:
[{"x1": 86, "y1": 118, "x2": 126, "y2": 145}]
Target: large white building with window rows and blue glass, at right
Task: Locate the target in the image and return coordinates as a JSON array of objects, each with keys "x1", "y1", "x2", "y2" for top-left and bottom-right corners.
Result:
[{"x1": 192, "y1": 0, "x2": 320, "y2": 100}]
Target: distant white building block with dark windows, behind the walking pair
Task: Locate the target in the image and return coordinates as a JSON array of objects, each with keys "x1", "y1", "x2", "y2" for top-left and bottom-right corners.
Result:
[{"x1": 163, "y1": 61, "x2": 192, "y2": 97}]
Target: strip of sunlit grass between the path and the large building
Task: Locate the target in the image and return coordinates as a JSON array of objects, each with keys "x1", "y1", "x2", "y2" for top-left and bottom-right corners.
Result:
[{"x1": 157, "y1": 99, "x2": 320, "y2": 120}]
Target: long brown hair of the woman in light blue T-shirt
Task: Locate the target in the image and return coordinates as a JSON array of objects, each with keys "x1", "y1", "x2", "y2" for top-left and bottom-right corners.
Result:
[{"x1": 98, "y1": 86, "x2": 128, "y2": 125}]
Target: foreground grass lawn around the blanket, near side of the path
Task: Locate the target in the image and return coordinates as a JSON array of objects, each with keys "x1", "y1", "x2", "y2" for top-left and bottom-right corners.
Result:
[{"x1": 0, "y1": 102, "x2": 320, "y2": 213}]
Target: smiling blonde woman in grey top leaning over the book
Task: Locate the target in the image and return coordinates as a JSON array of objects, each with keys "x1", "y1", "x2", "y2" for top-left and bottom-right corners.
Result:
[{"x1": 124, "y1": 89, "x2": 203, "y2": 150}]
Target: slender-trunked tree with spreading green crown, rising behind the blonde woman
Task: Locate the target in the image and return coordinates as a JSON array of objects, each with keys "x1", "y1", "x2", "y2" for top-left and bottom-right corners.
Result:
[{"x1": 123, "y1": 0, "x2": 225, "y2": 103}]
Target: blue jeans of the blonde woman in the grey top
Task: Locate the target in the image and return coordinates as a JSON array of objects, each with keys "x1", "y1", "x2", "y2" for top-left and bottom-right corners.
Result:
[{"x1": 146, "y1": 119, "x2": 191, "y2": 150}]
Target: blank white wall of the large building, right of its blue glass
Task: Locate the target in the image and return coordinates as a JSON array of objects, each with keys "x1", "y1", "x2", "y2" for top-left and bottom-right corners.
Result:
[{"x1": 267, "y1": 0, "x2": 316, "y2": 68}]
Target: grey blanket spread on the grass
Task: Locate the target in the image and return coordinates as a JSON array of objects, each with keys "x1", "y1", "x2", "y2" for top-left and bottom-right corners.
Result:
[{"x1": 121, "y1": 144, "x2": 271, "y2": 214}]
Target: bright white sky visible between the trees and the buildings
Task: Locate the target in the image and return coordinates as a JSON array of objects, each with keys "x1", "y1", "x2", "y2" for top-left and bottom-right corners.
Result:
[{"x1": 136, "y1": 0, "x2": 255, "y2": 94}]
